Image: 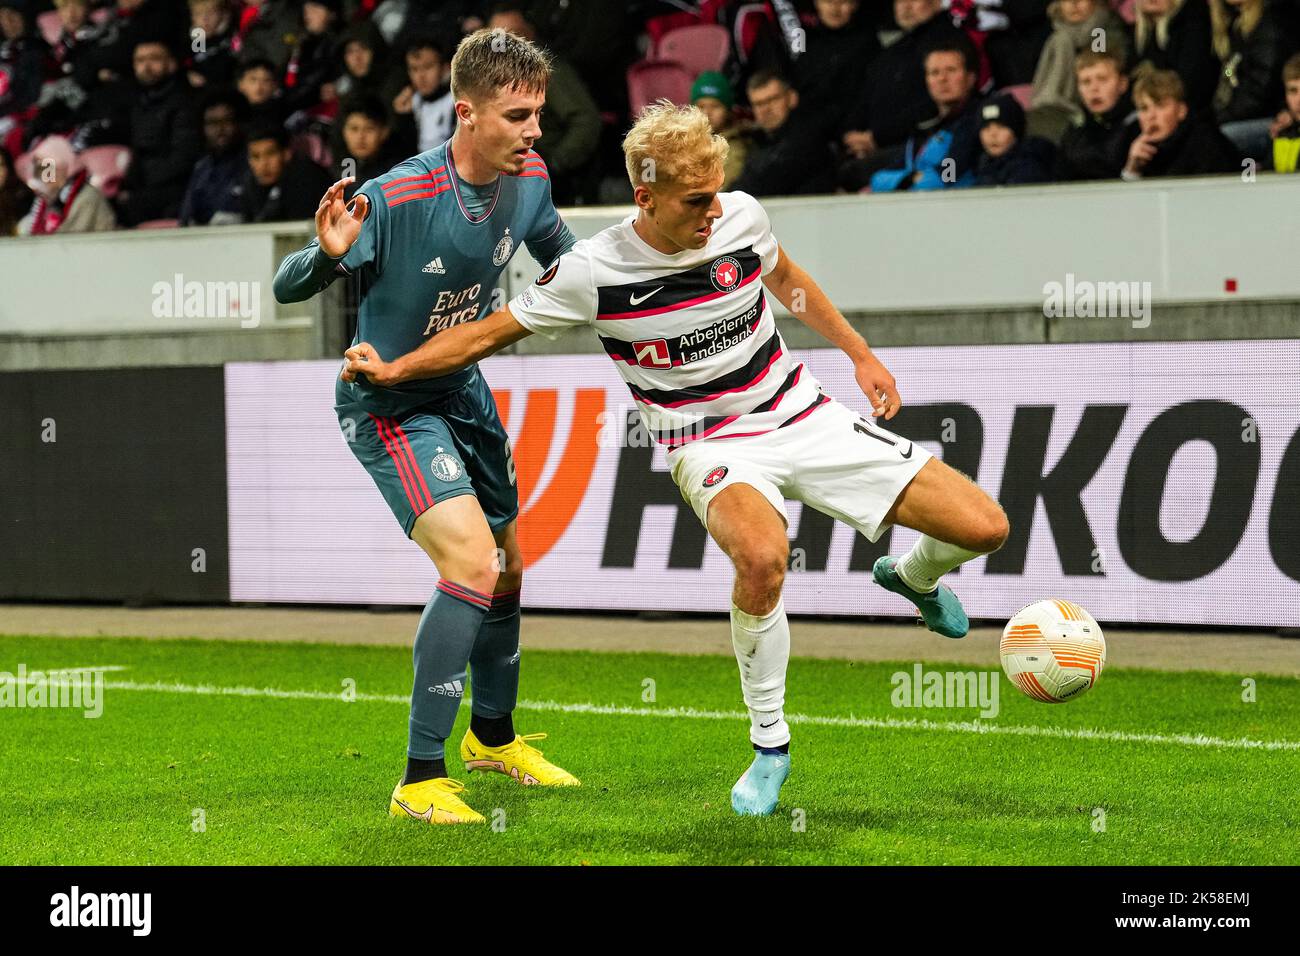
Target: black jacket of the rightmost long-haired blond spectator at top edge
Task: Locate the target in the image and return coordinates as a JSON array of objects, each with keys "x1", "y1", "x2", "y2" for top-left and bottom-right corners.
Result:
[{"x1": 1212, "y1": 0, "x2": 1296, "y2": 124}]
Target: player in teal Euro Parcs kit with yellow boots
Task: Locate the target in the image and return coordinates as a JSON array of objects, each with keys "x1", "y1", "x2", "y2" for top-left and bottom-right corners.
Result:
[{"x1": 274, "y1": 30, "x2": 579, "y2": 823}]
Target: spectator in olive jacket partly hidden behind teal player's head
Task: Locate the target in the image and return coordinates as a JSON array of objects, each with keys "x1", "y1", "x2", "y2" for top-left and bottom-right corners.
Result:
[{"x1": 488, "y1": 0, "x2": 601, "y2": 206}]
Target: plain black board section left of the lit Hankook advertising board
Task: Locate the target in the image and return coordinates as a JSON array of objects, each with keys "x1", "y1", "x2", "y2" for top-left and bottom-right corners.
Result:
[{"x1": 0, "y1": 367, "x2": 230, "y2": 602}]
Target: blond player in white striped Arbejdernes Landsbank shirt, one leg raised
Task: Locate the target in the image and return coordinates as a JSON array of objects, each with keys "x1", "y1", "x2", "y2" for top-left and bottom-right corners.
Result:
[{"x1": 347, "y1": 103, "x2": 1008, "y2": 816}]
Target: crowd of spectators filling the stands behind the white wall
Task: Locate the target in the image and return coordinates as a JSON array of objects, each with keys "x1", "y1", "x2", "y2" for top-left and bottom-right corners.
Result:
[{"x1": 0, "y1": 0, "x2": 1300, "y2": 235}]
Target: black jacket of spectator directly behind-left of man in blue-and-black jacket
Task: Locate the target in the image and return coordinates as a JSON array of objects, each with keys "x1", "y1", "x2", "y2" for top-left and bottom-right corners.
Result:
[{"x1": 845, "y1": 10, "x2": 963, "y2": 148}]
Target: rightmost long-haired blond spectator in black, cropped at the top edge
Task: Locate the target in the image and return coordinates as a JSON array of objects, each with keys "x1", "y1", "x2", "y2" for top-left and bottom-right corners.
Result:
[{"x1": 1210, "y1": 0, "x2": 1291, "y2": 160}]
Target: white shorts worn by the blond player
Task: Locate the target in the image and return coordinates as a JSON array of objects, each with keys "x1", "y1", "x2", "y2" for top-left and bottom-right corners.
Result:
[{"x1": 668, "y1": 399, "x2": 932, "y2": 541}]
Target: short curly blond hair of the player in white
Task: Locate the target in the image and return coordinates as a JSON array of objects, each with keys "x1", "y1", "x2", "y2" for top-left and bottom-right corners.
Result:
[{"x1": 623, "y1": 100, "x2": 731, "y2": 189}]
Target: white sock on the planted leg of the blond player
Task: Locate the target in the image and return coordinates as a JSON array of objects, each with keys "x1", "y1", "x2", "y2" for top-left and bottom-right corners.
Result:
[{"x1": 732, "y1": 601, "x2": 790, "y2": 747}]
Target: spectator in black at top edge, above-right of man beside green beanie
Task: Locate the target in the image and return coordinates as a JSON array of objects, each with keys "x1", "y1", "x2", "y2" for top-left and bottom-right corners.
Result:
[{"x1": 792, "y1": 0, "x2": 880, "y2": 139}]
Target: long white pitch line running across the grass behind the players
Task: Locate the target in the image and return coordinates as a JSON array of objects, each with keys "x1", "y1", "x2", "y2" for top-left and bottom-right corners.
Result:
[{"x1": 73, "y1": 680, "x2": 1300, "y2": 750}]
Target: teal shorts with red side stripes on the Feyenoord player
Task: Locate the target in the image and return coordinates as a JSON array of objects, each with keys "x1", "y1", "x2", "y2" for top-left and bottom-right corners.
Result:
[{"x1": 334, "y1": 369, "x2": 519, "y2": 537}]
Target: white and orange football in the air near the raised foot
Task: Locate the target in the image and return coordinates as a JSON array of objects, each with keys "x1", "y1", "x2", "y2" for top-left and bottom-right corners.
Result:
[{"x1": 998, "y1": 600, "x2": 1106, "y2": 704}]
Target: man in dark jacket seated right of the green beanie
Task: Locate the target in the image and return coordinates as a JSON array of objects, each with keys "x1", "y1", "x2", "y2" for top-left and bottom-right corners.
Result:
[{"x1": 732, "y1": 70, "x2": 833, "y2": 196}]
